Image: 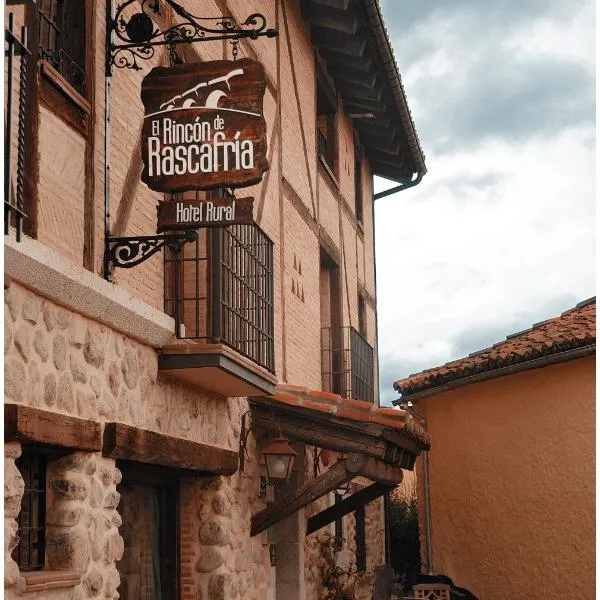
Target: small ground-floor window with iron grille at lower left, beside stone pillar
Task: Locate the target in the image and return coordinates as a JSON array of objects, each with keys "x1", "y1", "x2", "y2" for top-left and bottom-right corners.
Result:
[{"x1": 12, "y1": 448, "x2": 47, "y2": 571}]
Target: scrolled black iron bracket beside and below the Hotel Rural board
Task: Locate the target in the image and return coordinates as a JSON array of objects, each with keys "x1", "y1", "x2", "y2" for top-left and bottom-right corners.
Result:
[{"x1": 104, "y1": 229, "x2": 198, "y2": 281}]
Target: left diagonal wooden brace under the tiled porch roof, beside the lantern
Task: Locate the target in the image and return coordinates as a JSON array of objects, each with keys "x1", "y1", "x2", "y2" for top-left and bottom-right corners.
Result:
[{"x1": 250, "y1": 458, "x2": 358, "y2": 536}]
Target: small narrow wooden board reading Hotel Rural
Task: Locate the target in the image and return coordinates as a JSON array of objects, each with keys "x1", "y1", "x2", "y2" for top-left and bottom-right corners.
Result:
[{"x1": 156, "y1": 198, "x2": 254, "y2": 233}]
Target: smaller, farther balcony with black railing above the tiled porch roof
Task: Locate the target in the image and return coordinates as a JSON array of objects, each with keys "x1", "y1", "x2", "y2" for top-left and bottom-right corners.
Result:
[{"x1": 321, "y1": 327, "x2": 374, "y2": 403}]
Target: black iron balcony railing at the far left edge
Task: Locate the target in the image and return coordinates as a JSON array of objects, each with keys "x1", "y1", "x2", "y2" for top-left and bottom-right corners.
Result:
[{"x1": 4, "y1": 13, "x2": 31, "y2": 241}]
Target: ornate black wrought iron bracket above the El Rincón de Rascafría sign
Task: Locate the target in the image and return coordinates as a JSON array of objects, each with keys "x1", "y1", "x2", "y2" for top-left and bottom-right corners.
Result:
[{"x1": 106, "y1": 0, "x2": 279, "y2": 77}]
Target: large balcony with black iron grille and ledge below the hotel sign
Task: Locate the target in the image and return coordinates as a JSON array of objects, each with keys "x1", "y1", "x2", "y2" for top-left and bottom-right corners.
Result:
[{"x1": 159, "y1": 225, "x2": 276, "y2": 396}]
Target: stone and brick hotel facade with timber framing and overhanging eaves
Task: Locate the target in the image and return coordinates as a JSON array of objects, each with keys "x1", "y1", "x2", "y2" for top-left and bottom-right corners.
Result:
[{"x1": 4, "y1": 0, "x2": 428, "y2": 600}]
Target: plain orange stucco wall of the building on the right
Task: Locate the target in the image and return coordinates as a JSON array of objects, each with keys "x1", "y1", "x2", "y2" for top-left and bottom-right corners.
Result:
[{"x1": 415, "y1": 357, "x2": 595, "y2": 600}]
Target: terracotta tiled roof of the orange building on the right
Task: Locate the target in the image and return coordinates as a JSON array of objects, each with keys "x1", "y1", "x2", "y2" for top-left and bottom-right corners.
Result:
[{"x1": 394, "y1": 297, "x2": 596, "y2": 396}]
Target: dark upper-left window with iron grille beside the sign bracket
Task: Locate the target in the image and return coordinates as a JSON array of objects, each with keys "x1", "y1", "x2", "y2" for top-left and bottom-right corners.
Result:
[{"x1": 38, "y1": 0, "x2": 87, "y2": 95}]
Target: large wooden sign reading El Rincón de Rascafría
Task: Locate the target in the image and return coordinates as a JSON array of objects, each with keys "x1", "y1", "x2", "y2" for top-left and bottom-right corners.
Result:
[{"x1": 142, "y1": 58, "x2": 269, "y2": 192}]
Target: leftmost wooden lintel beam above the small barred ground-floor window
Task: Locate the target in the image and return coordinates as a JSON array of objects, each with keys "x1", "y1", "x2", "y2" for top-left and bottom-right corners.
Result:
[{"x1": 4, "y1": 404, "x2": 102, "y2": 452}]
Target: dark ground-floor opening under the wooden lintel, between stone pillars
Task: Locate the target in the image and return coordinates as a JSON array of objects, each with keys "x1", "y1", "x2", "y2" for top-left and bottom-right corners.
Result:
[{"x1": 117, "y1": 462, "x2": 179, "y2": 600}]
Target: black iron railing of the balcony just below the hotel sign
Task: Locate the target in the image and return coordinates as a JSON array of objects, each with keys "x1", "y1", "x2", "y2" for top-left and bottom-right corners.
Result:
[{"x1": 165, "y1": 224, "x2": 275, "y2": 372}]
